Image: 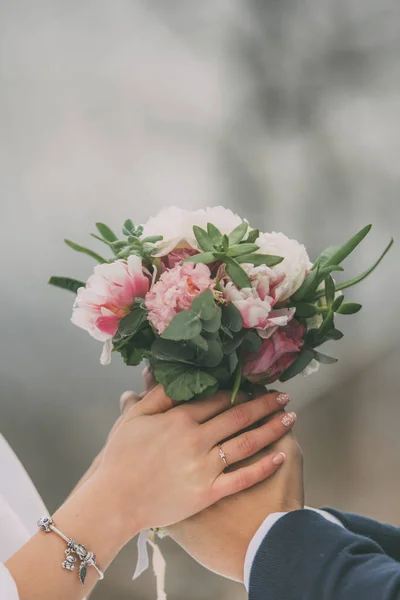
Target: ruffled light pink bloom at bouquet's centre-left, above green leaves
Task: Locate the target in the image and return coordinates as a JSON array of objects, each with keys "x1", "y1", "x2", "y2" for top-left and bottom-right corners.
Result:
[{"x1": 145, "y1": 262, "x2": 215, "y2": 334}]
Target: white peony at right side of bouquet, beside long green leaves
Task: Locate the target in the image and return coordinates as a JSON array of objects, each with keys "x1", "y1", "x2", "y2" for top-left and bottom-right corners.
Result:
[{"x1": 256, "y1": 231, "x2": 312, "y2": 302}]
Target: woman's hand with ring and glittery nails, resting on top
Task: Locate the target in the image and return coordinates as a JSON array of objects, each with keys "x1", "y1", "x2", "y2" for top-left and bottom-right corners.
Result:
[{"x1": 93, "y1": 386, "x2": 291, "y2": 536}]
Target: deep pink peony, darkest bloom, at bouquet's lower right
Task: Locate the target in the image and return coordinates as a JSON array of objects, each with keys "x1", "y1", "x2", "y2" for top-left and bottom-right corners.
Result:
[{"x1": 243, "y1": 319, "x2": 306, "y2": 384}]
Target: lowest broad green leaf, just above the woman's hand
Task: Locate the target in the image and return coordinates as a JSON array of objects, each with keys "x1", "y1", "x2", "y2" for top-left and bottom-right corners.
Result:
[{"x1": 153, "y1": 360, "x2": 217, "y2": 402}]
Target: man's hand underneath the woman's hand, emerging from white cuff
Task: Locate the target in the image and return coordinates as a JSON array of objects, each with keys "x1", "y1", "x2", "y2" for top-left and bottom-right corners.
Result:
[{"x1": 167, "y1": 433, "x2": 304, "y2": 581}]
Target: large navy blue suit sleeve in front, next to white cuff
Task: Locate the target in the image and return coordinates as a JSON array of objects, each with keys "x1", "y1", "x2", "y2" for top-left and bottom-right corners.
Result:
[{"x1": 249, "y1": 510, "x2": 400, "y2": 600}]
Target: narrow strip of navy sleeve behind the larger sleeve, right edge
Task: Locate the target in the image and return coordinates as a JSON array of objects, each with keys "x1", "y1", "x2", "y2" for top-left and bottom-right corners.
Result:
[{"x1": 324, "y1": 508, "x2": 400, "y2": 562}]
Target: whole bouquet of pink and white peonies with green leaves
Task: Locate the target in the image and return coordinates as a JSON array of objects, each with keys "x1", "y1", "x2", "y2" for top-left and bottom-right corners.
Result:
[{"x1": 49, "y1": 207, "x2": 393, "y2": 401}]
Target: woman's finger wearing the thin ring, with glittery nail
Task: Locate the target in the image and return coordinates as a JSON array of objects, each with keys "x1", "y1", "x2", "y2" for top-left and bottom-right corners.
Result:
[{"x1": 210, "y1": 413, "x2": 296, "y2": 472}]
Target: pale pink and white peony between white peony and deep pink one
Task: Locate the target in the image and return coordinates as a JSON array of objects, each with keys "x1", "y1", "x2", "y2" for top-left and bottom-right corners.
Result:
[{"x1": 221, "y1": 265, "x2": 295, "y2": 338}]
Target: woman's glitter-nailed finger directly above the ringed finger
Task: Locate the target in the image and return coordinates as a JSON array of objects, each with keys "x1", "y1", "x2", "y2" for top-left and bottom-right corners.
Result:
[{"x1": 202, "y1": 393, "x2": 289, "y2": 448}]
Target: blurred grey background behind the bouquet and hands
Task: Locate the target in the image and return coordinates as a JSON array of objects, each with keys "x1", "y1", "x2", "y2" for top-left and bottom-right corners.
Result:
[{"x1": 0, "y1": 0, "x2": 400, "y2": 600}]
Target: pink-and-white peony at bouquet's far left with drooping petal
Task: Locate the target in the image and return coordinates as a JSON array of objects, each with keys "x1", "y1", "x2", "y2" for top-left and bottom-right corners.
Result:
[{"x1": 71, "y1": 256, "x2": 149, "y2": 363}]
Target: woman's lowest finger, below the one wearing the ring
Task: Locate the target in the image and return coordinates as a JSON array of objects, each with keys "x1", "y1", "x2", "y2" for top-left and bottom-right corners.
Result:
[{"x1": 213, "y1": 452, "x2": 286, "y2": 502}]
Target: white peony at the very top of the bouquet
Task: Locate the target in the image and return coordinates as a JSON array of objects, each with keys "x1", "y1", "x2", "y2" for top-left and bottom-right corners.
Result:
[{"x1": 143, "y1": 206, "x2": 247, "y2": 256}]
